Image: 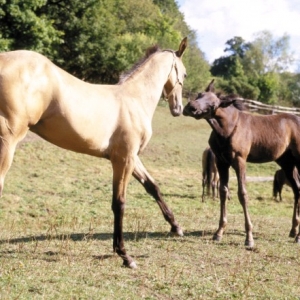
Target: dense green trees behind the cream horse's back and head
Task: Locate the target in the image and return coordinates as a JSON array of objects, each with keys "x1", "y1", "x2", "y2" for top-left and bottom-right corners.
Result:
[{"x1": 0, "y1": 0, "x2": 209, "y2": 90}]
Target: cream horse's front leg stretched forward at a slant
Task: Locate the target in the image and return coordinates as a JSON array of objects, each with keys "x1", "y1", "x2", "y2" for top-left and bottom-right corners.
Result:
[{"x1": 133, "y1": 157, "x2": 183, "y2": 236}]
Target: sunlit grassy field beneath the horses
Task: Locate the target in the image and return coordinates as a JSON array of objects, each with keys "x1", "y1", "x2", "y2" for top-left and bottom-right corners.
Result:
[{"x1": 0, "y1": 102, "x2": 300, "y2": 300}]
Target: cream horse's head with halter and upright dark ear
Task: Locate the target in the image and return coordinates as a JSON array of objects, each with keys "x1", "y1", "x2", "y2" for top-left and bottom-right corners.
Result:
[{"x1": 164, "y1": 38, "x2": 187, "y2": 117}]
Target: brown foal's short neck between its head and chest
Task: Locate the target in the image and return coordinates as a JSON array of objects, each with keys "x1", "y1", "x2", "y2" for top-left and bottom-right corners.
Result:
[{"x1": 207, "y1": 107, "x2": 239, "y2": 139}]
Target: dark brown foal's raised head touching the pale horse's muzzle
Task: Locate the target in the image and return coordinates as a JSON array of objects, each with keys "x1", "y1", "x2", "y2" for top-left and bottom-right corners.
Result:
[{"x1": 183, "y1": 80, "x2": 244, "y2": 120}]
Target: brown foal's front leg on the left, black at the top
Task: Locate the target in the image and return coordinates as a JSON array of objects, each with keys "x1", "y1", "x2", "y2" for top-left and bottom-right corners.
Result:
[{"x1": 213, "y1": 160, "x2": 230, "y2": 241}]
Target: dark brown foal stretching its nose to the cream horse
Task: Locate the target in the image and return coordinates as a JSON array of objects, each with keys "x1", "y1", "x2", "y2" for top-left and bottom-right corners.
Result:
[{"x1": 183, "y1": 81, "x2": 300, "y2": 247}]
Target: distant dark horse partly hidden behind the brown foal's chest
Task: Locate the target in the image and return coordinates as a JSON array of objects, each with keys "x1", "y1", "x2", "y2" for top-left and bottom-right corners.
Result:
[{"x1": 202, "y1": 147, "x2": 219, "y2": 202}]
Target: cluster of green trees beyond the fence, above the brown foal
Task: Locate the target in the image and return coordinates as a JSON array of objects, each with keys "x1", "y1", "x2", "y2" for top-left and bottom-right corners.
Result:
[{"x1": 211, "y1": 31, "x2": 296, "y2": 103}]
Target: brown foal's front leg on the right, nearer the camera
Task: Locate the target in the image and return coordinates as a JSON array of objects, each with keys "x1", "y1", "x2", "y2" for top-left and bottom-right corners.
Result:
[{"x1": 232, "y1": 157, "x2": 254, "y2": 248}]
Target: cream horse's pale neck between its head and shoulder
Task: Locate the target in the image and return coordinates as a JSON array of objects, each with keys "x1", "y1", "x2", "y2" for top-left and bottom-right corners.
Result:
[{"x1": 122, "y1": 52, "x2": 173, "y2": 117}]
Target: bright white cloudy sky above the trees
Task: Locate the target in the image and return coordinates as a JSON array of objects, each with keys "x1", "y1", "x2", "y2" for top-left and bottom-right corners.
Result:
[{"x1": 176, "y1": 0, "x2": 300, "y2": 70}]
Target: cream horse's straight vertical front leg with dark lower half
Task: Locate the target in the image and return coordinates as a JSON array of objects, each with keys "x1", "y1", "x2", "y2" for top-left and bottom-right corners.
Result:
[{"x1": 112, "y1": 157, "x2": 136, "y2": 269}]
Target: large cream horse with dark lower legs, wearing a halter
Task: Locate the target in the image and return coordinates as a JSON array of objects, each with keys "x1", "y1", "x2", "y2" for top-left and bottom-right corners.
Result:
[{"x1": 0, "y1": 38, "x2": 187, "y2": 268}]
